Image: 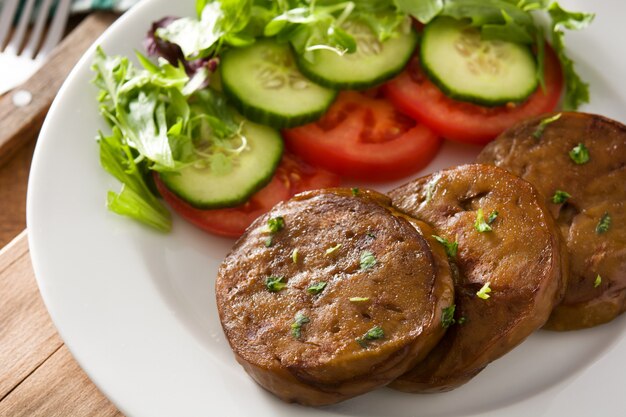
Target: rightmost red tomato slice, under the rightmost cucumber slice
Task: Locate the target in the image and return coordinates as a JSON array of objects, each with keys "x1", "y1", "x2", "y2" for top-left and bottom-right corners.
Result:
[{"x1": 383, "y1": 46, "x2": 563, "y2": 144}]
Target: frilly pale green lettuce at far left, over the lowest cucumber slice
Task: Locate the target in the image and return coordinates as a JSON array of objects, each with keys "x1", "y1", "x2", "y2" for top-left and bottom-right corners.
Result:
[{"x1": 92, "y1": 48, "x2": 246, "y2": 231}]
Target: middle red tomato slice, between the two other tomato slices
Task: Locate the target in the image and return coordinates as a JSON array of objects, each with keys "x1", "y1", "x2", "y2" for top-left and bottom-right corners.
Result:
[{"x1": 282, "y1": 91, "x2": 441, "y2": 181}]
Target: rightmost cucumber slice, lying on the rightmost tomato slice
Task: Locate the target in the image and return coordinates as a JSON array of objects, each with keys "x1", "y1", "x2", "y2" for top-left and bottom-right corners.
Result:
[{"x1": 420, "y1": 17, "x2": 538, "y2": 106}]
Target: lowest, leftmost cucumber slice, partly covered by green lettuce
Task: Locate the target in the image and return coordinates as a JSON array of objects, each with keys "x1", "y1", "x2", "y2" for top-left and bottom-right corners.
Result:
[{"x1": 159, "y1": 122, "x2": 283, "y2": 209}]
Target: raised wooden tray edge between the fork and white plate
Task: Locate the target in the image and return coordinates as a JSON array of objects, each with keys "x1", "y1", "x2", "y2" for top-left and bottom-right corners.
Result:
[{"x1": 0, "y1": 12, "x2": 117, "y2": 166}]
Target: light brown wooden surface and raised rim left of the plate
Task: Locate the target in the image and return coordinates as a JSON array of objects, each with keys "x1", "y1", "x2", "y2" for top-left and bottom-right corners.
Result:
[{"x1": 0, "y1": 13, "x2": 122, "y2": 417}]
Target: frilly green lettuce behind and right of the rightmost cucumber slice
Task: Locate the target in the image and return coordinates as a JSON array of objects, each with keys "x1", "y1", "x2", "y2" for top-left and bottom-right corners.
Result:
[{"x1": 410, "y1": 0, "x2": 595, "y2": 110}]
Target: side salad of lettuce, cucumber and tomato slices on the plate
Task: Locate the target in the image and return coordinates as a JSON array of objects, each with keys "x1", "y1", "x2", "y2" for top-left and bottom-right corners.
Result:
[{"x1": 92, "y1": 0, "x2": 593, "y2": 236}]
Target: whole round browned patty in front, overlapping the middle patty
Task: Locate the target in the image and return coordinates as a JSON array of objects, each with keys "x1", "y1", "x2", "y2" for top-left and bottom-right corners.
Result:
[{"x1": 216, "y1": 190, "x2": 453, "y2": 406}]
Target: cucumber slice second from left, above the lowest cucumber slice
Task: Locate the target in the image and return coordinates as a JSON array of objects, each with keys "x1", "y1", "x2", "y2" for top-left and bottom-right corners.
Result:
[{"x1": 220, "y1": 39, "x2": 337, "y2": 129}]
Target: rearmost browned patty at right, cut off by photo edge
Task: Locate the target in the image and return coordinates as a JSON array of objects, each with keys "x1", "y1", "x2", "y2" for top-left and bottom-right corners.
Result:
[{"x1": 478, "y1": 113, "x2": 626, "y2": 330}]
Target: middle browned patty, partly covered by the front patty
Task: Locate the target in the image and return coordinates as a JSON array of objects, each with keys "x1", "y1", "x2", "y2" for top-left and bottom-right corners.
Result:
[{"x1": 390, "y1": 165, "x2": 566, "y2": 392}]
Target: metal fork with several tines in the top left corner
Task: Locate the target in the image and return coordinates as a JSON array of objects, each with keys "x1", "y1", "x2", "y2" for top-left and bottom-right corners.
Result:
[{"x1": 0, "y1": 0, "x2": 70, "y2": 95}]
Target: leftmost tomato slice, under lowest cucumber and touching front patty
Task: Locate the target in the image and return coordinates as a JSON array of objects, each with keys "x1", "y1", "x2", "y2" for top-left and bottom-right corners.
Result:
[{"x1": 155, "y1": 153, "x2": 340, "y2": 237}]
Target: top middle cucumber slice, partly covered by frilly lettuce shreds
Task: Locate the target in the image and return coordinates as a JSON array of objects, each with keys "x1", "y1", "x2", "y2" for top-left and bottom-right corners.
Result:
[{"x1": 298, "y1": 21, "x2": 418, "y2": 90}]
